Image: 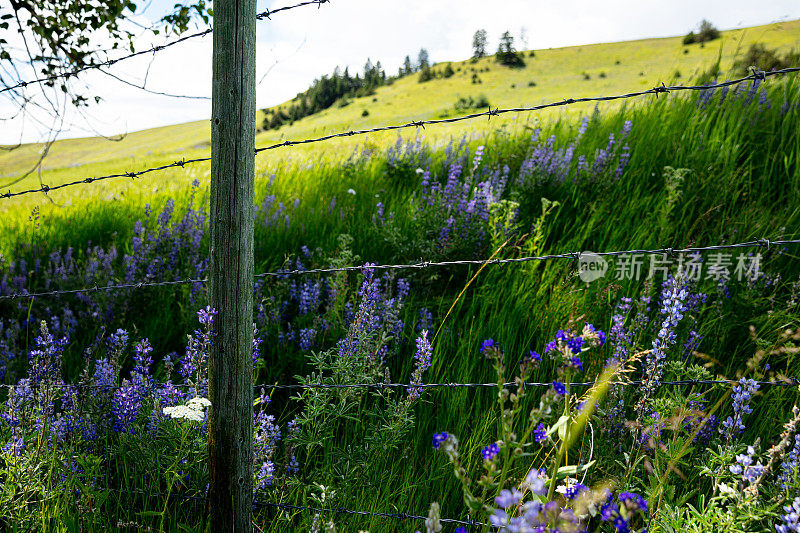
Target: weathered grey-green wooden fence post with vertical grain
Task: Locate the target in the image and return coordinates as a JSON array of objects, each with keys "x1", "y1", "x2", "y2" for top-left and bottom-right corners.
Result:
[{"x1": 208, "y1": 0, "x2": 256, "y2": 533}]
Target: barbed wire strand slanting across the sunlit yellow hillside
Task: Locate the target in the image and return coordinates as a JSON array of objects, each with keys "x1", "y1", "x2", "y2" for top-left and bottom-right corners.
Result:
[{"x1": 0, "y1": 66, "x2": 800, "y2": 198}]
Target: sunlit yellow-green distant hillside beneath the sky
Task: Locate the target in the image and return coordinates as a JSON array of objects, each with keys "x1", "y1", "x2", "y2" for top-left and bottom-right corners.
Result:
[{"x1": 0, "y1": 20, "x2": 800, "y2": 222}]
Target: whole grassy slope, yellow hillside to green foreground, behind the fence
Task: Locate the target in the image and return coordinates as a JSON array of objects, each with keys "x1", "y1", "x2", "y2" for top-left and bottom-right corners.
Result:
[{"x1": 0, "y1": 16, "x2": 800, "y2": 533}]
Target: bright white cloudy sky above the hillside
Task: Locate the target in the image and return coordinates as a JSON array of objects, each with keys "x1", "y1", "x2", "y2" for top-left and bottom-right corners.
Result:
[{"x1": 0, "y1": 0, "x2": 800, "y2": 144}]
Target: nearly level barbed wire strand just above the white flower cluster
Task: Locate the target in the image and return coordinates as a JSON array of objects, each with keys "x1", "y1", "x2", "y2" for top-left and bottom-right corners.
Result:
[{"x1": 0, "y1": 377, "x2": 800, "y2": 392}]
